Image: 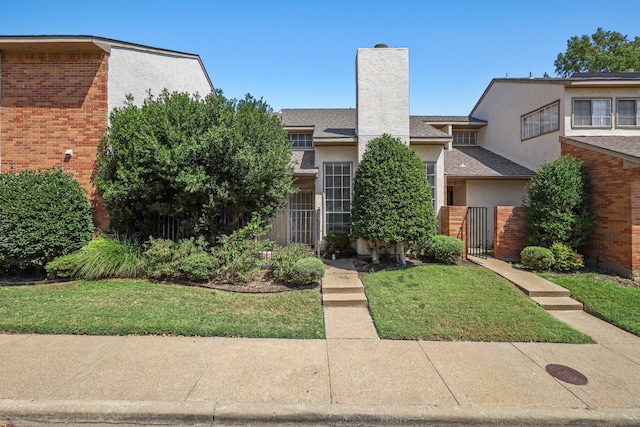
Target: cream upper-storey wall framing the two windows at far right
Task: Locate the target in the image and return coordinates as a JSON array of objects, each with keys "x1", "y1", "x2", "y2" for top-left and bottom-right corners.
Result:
[{"x1": 563, "y1": 87, "x2": 640, "y2": 136}]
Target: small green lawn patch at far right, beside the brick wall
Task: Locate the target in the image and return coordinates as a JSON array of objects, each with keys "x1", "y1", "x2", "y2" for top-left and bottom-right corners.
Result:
[{"x1": 539, "y1": 273, "x2": 640, "y2": 336}]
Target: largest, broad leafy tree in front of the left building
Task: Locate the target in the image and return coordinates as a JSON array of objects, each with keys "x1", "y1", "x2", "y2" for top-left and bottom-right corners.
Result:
[{"x1": 96, "y1": 90, "x2": 293, "y2": 243}]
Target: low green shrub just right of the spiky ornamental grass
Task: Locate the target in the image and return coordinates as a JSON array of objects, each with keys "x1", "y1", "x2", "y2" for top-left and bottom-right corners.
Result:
[{"x1": 144, "y1": 238, "x2": 215, "y2": 281}]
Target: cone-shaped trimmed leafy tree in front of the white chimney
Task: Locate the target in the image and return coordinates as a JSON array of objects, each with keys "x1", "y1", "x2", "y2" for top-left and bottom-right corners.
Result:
[{"x1": 351, "y1": 134, "x2": 436, "y2": 264}]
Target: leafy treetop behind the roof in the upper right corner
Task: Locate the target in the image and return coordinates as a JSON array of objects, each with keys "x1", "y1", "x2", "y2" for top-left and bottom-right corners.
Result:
[{"x1": 554, "y1": 28, "x2": 640, "y2": 77}]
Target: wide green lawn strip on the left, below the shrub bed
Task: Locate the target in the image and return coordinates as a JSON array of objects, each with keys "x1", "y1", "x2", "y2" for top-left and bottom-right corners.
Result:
[{"x1": 0, "y1": 280, "x2": 324, "y2": 338}]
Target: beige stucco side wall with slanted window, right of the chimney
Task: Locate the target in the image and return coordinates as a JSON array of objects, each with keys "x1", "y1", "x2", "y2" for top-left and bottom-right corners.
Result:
[{"x1": 472, "y1": 79, "x2": 565, "y2": 170}]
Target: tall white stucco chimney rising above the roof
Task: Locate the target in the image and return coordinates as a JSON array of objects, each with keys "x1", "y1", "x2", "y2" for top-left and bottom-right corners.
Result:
[{"x1": 356, "y1": 45, "x2": 409, "y2": 159}]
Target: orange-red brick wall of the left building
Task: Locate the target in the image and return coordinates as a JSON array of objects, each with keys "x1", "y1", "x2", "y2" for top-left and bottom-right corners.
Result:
[{"x1": 0, "y1": 52, "x2": 108, "y2": 226}]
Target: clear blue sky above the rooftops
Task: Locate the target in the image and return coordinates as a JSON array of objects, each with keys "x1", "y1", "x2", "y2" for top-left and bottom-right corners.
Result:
[{"x1": 0, "y1": 0, "x2": 640, "y2": 115}]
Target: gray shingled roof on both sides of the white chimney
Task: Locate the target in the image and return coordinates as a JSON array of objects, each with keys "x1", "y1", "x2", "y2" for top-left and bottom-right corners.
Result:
[{"x1": 277, "y1": 108, "x2": 452, "y2": 139}]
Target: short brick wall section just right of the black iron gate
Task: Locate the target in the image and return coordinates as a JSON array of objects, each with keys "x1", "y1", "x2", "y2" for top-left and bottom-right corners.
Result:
[{"x1": 493, "y1": 206, "x2": 527, "y2": 261}]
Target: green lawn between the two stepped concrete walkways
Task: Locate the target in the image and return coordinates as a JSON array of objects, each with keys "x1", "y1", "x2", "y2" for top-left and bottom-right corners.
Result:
[{"x1": 362, "y1": 265, "x2": 594, "y2": 343}]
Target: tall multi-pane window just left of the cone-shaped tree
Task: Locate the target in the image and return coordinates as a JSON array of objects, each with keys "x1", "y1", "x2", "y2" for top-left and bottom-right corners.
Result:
[{"x1": 324, "y1": 162, "x2": 351, "y2": 233}]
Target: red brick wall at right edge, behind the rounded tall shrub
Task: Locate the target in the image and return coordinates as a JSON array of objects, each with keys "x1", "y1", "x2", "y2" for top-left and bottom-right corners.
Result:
[{"x1": 561, "y1": 142, "x2": 640, "y2": 276}]
